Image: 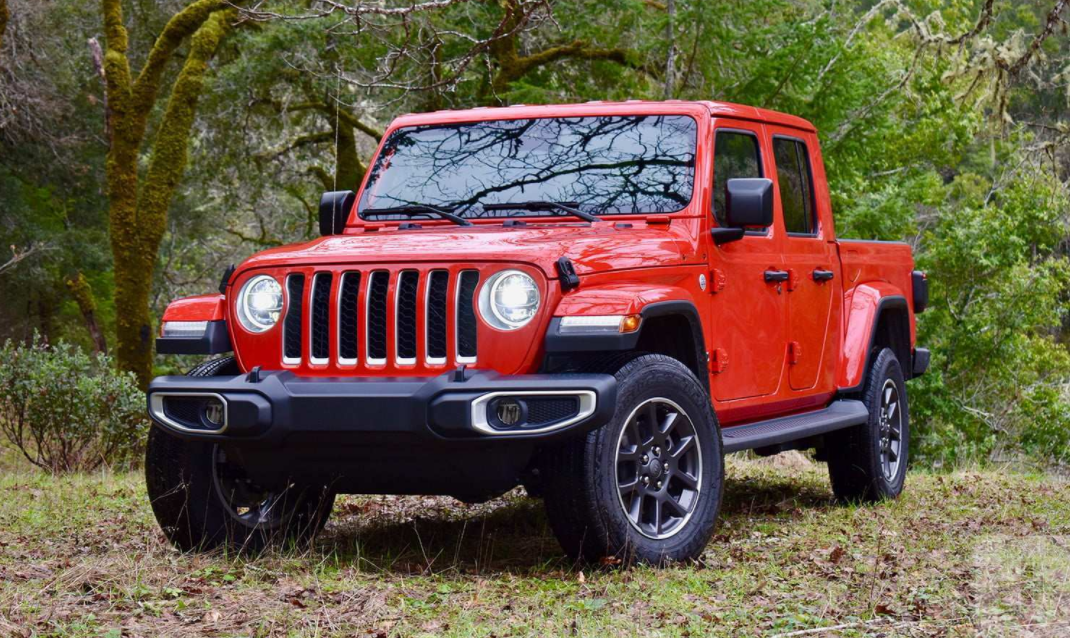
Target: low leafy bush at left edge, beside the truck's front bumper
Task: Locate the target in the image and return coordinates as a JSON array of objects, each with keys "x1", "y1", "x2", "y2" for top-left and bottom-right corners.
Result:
[{"x1": 0, "y1": 335, "x2": 149, "y2": 472}]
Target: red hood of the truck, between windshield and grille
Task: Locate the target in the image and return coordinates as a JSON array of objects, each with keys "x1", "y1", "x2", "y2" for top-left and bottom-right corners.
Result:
[{"x1": 239, "y1": 219, "x2": 697, "y2": 276}]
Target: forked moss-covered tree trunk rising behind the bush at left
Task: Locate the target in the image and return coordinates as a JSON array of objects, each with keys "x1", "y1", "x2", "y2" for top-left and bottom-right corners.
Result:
[{"x1": 102, "y1": 0, "x2": 234, "y2": 385}]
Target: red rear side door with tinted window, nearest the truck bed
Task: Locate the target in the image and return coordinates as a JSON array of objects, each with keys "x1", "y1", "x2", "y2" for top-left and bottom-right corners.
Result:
[{"x1": 769, "y1": 131, "x2": 840, "y2": 392}]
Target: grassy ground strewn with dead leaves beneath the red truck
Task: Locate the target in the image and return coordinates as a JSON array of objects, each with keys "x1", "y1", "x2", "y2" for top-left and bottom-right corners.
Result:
[{"x1": 0, "y1": 456, "x2": 1070, "y2": 637}]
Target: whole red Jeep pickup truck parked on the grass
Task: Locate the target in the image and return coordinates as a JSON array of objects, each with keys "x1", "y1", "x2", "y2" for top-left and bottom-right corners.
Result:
[{"x1": 147, "y1": 101, "x2": 929, "y2": 563}]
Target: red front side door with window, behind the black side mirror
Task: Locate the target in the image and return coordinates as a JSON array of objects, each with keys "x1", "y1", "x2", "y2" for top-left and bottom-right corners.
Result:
[{"x1": 708, "y1": 118, "x2": 786, "y2": 400}]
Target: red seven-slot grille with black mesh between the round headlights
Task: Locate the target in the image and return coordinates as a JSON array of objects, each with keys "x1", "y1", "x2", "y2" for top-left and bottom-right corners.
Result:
[{"x1": 282, "y1": 269, "x2": 479, "y2": 366}]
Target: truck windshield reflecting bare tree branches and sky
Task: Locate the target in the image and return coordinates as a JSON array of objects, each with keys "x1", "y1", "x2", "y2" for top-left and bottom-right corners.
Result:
[{"x1": 360, "y1": 116, "x2": 698, "y2": 219}]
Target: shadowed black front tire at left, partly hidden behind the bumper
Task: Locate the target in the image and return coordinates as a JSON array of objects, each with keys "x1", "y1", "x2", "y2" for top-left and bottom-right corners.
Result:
[{"x1": 144, "y1": 356, "x2": 334, "y2": 551}]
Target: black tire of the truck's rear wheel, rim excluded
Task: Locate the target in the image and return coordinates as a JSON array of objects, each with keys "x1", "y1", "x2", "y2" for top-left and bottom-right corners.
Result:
[{"x1": 825, "y1": 348, "x2": 911, "y2": 502}]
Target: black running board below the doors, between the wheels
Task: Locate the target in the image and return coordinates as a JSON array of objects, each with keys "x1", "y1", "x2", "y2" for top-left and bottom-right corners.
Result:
[{"x1": 721, "y1": 399, "x2": 869, "y2": 454}]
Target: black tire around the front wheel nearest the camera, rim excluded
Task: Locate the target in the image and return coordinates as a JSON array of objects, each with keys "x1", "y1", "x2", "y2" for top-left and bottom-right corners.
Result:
[{"x1": 542, "y1": 354, "x2": 724, "y2": 565}]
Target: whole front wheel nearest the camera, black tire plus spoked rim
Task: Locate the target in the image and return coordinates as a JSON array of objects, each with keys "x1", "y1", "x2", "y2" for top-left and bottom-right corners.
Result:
[{"x1": 544, "y1": 354, "x2": 724, "y2": 564}]
